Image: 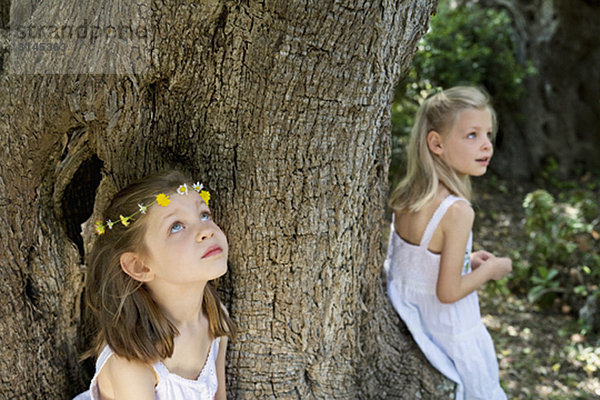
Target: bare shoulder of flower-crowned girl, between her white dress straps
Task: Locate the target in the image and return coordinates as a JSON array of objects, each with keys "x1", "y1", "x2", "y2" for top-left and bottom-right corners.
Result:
[{"x1": 98, "y1": 355, "x2": 156, "y2": 400}]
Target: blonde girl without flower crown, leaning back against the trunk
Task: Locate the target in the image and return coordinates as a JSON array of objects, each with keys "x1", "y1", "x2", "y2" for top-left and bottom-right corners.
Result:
[{"x1": 384, "y1": 87, "x2": 512, "y2": 400}]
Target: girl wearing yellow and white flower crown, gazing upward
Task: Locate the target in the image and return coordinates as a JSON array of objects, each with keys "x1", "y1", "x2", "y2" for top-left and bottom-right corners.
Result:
[{"x1": 76, "y1": 172, "x2": 234, "y2": 400}]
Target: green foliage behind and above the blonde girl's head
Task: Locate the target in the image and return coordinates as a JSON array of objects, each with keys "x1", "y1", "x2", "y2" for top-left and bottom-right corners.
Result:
[{"x1": 390, "y1": 0, "x2": 535, "y2": 188}]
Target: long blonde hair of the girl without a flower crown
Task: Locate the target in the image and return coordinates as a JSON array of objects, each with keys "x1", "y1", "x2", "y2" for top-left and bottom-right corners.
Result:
[{"x1": 389, "y1": 86, "x2": 497, "y2": 212}]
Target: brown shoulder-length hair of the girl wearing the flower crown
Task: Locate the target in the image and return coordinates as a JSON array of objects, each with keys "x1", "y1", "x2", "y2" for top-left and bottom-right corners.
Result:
[{"x1": 85, "y1": 171, "x2": 235, "y2": 363}]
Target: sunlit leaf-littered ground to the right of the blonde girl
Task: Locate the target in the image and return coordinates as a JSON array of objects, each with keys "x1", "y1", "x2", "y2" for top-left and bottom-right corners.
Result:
[{"x1": 473, "y1": 178, "x2": 600, "y2": 400}]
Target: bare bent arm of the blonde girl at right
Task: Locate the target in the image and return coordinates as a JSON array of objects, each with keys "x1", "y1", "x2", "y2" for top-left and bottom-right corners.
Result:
[{"x1": 436, "y1": 201, "x2": 512, "y2": 303}]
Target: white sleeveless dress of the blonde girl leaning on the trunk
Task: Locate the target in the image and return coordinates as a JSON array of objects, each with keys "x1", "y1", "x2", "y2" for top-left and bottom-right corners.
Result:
[{"x1": 384, "y1": 195, "x2": 506, "y2": 400}]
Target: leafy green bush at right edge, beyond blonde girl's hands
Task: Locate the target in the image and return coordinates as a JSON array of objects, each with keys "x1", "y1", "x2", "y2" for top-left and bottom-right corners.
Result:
[{"x1": 511, "y1": 189, "x2": 600, "y2": 308}]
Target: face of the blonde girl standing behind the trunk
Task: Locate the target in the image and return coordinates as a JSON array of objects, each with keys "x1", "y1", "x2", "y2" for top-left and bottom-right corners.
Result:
[{"x1": 440, "y1": 108, "x2": 494, "y2": 176}]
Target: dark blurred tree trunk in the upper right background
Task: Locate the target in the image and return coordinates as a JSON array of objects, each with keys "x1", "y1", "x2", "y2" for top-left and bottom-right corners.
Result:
[{"x1": 482, "y1": 0, "x2": 600, "y2": 178}]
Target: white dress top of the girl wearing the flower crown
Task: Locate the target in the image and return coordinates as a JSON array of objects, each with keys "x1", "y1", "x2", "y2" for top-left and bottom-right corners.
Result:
[{"x1": 73, "y1": 338, "x2": 219, "y2": 400}]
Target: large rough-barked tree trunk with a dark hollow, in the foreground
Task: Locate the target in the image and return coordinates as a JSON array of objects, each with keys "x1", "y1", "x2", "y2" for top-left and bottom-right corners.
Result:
[{"x1": 0, "y1": 0, "x2": 452, "y2": 399}]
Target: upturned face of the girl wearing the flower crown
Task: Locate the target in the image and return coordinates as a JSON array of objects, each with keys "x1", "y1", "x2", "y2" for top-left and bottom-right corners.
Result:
[{"x1": 145, "y1": 190, "x2": 228, "y2": 285}]
